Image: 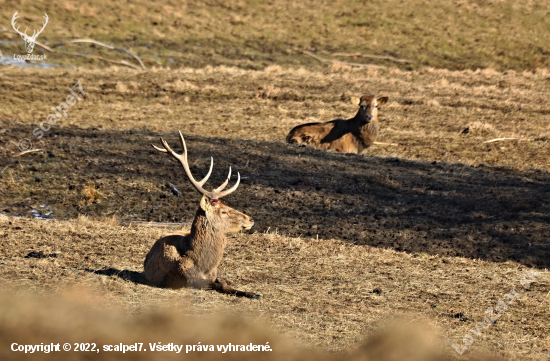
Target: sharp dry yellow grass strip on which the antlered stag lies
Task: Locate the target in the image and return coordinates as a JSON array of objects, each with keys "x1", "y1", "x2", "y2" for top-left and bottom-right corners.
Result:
[{"x1": 0, "y1": 212, "x2": 550, "y2": 360}]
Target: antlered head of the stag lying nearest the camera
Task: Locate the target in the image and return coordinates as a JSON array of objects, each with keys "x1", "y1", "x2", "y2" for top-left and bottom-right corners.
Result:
[{"x1": 151, "y1": 132, "x2": 254, "y2": 233}]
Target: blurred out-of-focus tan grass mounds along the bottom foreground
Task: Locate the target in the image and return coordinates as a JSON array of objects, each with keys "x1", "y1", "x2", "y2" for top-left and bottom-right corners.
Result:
[{"x1": 0, "y1": 289, "x2": 478, "y2": 361}]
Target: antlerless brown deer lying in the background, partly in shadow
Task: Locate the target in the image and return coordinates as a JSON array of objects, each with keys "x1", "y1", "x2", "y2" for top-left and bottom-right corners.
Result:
[{"x1": 286, "y1": 95, "x2": 388, "y2": 153}]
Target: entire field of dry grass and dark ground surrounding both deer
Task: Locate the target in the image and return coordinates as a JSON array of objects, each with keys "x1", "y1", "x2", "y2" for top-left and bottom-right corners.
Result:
[{"x1": 0, "y1": 0, "x2": 550, "y2": 361}]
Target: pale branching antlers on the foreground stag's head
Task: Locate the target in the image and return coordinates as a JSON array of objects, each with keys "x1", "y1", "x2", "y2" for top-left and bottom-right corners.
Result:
[{"x1": 155, "y1": 131, "x2": 241, "y2": 199}]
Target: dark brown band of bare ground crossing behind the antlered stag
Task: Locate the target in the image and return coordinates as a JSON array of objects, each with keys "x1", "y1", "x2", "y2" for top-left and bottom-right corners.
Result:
[{"x1": 0, "y1": 122, "x2": 550, "y2": 268}]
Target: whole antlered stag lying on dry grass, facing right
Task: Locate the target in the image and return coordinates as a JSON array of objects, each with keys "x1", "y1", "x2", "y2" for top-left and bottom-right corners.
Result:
[{"x1": 143, "y1": 132, "x2": 261, "y2": 298}]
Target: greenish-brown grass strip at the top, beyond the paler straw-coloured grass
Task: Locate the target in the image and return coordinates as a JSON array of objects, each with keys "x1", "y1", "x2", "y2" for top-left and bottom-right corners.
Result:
[{"x1": 0, "y1": 0, "x2": 550, "y2": 71}]
